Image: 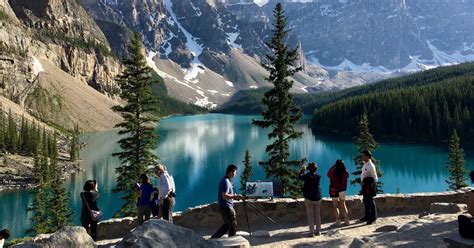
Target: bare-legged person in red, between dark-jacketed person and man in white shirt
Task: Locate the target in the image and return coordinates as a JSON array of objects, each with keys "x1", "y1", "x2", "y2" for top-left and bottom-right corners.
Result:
[{"x1": 328, "y1": 159, "x2": 349, "y2": 225}]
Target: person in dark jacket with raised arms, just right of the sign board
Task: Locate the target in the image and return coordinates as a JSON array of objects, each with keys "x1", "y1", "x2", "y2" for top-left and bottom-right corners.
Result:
[{"x1": 298, "y1": 162, "x2": 322, "y2": 237}]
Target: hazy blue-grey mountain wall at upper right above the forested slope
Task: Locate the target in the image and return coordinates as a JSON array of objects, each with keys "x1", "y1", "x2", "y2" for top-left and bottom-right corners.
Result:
[{"x1": 227, "y1": 0, "x2": 474, "y2": 73}]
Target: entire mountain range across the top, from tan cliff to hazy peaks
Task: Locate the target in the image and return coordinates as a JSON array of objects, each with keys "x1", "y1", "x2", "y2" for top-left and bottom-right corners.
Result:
[{"x1": 0, "y1": 0, "x2": 474, "y2": 128}]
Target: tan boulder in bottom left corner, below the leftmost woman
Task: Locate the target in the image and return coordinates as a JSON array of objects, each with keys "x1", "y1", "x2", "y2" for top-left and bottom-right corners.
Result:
[{"x1": 13, "y1": 226, "x2": 96, "y2": 248}]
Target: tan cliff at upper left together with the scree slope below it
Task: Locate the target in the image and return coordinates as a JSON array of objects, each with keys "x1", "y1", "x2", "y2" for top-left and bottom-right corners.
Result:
[{"x1": 0, "y1": 0, "x2": 121, "y2": 130}]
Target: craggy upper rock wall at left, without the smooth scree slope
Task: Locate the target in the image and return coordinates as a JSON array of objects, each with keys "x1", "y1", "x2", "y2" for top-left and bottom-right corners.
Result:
[{"x1": 0, "y1": 0, "x2": 121, "y2": 99}]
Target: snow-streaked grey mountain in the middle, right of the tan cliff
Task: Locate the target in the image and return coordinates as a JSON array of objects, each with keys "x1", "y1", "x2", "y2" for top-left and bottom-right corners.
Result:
[{"x1": 80, "y1": 0, "x2": 363, "y2": 107}]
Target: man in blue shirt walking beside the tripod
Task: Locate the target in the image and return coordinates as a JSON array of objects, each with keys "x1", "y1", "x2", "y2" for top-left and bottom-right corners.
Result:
[{"x1": 211, "y1": 164, "x2": 242, "y2": 239}]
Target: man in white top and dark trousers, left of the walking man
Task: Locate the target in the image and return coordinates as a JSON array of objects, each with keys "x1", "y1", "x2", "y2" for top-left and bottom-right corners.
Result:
[{"x1": 155, "y1": 164, "x2": 176, "y2": 223}]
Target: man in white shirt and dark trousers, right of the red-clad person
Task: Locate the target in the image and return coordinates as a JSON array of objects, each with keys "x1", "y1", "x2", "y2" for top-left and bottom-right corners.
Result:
[{"x1": 360, "y1": 150, "x2": 379, "y2": 225}]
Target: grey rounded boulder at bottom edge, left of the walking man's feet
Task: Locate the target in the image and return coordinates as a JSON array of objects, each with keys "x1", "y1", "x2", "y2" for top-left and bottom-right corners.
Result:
[{"x1": 117, "y1": 220, "x2": 217, "y2": 248}]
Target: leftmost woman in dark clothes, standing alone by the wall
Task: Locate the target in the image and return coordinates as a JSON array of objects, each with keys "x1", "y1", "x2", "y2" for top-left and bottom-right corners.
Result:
[{"x1": 81, "y1": 180, "x2": 100, "y2": 241}]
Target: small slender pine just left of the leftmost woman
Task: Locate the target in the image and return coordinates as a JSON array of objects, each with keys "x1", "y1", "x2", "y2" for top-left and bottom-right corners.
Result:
[{"x1": 48, "y1": 134, "x2": 73, "y2": 231}]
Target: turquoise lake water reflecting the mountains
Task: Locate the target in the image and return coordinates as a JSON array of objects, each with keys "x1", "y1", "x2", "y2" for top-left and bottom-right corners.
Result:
[{"x1": 0, "y1": 114, "x2": 474, "y2": 237}]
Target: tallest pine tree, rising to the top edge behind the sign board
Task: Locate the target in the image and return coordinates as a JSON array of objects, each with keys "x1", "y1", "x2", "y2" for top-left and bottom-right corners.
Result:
[{"x1": 253, "y1": 3, "x2": 305, "y2": 196}]
